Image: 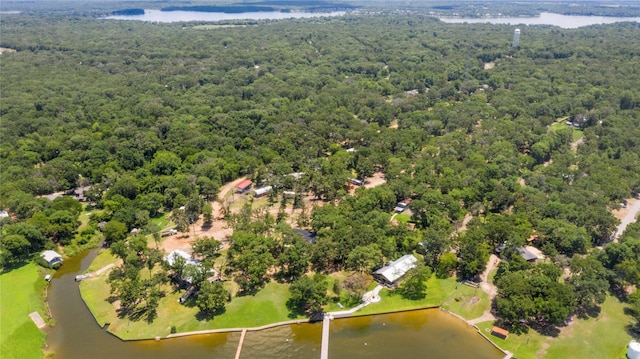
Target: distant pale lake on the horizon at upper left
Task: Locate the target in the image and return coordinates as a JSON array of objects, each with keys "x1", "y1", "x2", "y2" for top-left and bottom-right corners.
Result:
[{"x1": 105, "y1": 9, "x2": 346, "y2": 22}]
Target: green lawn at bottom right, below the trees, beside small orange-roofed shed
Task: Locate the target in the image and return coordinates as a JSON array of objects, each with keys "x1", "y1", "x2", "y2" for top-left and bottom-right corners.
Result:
[{"x1": 478, "y1": 296, "x2": 632, "y2": 359}]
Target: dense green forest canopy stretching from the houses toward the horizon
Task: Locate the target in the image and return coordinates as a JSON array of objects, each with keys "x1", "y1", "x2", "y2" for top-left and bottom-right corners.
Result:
[{"x1": 0, "y1": 3, "x2": 640, "y2": 334}]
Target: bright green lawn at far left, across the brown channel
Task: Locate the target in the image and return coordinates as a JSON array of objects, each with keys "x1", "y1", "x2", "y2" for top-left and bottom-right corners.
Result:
[{"x1": 0, "y1": 263, "x2": 47, "y2": 359}]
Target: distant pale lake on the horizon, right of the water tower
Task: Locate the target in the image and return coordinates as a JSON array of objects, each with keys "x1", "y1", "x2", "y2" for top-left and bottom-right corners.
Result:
[{"x1": 440, "y1": 12, "x2": 640, "y2": 29}]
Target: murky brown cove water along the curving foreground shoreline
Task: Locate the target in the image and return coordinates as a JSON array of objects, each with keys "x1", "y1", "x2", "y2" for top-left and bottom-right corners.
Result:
[{"x1": 47, "y1": 250, "x2": 504, "y2": 359}]
